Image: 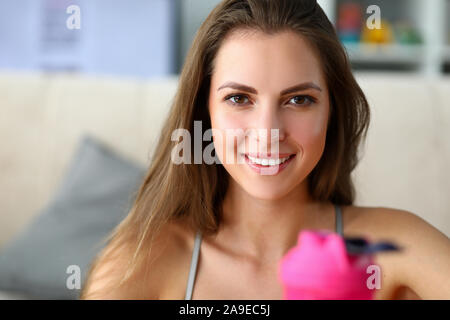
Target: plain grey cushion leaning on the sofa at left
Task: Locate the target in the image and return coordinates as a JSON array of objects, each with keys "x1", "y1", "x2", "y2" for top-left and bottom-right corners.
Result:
[{"x1": 0, "y1": 136, "x2": 145, "y2": 299}]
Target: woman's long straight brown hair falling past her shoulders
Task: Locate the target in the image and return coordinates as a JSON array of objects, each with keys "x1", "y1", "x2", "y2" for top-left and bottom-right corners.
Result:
[{"x1": 80, "y1": 0, "x2": 370, "y2": 298}]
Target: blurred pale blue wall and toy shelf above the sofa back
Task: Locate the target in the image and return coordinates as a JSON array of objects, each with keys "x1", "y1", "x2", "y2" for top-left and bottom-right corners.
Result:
[{"x1": 0, "y1": 0, "x2": 450, "y2": 77}]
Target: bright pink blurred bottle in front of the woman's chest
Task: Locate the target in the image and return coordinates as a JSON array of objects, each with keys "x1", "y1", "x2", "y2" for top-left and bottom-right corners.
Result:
[{"x1": 278, "y1": 230, "x2": 374, "y2": 300}]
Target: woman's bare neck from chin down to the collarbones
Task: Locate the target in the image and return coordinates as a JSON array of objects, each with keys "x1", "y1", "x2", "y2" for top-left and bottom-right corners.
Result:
[{"x1": 217, "y1": 179, "x2": 330, "y2": 265}]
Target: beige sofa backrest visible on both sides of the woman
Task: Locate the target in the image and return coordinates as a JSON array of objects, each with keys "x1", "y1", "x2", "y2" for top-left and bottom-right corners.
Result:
[{"x1": 0, "y1": 72, "x2": 450, "y2": 252}]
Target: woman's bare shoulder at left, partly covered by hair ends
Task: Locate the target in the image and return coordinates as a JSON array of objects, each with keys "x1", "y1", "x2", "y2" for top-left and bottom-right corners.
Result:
[{"x1": 81, "y1": 222, "x2": 193, "y2": 300}]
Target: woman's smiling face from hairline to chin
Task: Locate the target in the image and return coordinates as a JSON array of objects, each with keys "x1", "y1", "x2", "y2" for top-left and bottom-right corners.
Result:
[{"x1": 208, "y1": 31, "x2": 329, "y2": 199}]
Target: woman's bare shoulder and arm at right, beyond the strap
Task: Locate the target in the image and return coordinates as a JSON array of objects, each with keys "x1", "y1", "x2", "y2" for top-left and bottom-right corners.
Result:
[{"x1": 343, "y1": 206, "x2": 450, "y2": 299}]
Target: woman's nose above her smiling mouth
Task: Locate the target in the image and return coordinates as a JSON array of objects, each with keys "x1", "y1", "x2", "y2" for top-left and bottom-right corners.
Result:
[{"x1": 251, "y1": 104, "x2": 286, "y2": 152}]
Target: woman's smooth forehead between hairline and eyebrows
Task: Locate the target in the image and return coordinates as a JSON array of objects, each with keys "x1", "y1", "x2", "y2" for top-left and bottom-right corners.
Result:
[{"x1": 212, "y1": 31, "x2": 325, "y2": 92}]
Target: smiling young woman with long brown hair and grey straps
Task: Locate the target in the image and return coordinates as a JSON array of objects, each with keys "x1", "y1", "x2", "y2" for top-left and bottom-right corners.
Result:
[{"x1": 81, "y1": 0, "x2": 450, "y2": 299}]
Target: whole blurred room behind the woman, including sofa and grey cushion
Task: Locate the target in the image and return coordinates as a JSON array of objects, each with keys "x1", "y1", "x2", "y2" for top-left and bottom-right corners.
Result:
[{"x1": 0, "y1": 0, "x2": 450, "y2": 299}]
